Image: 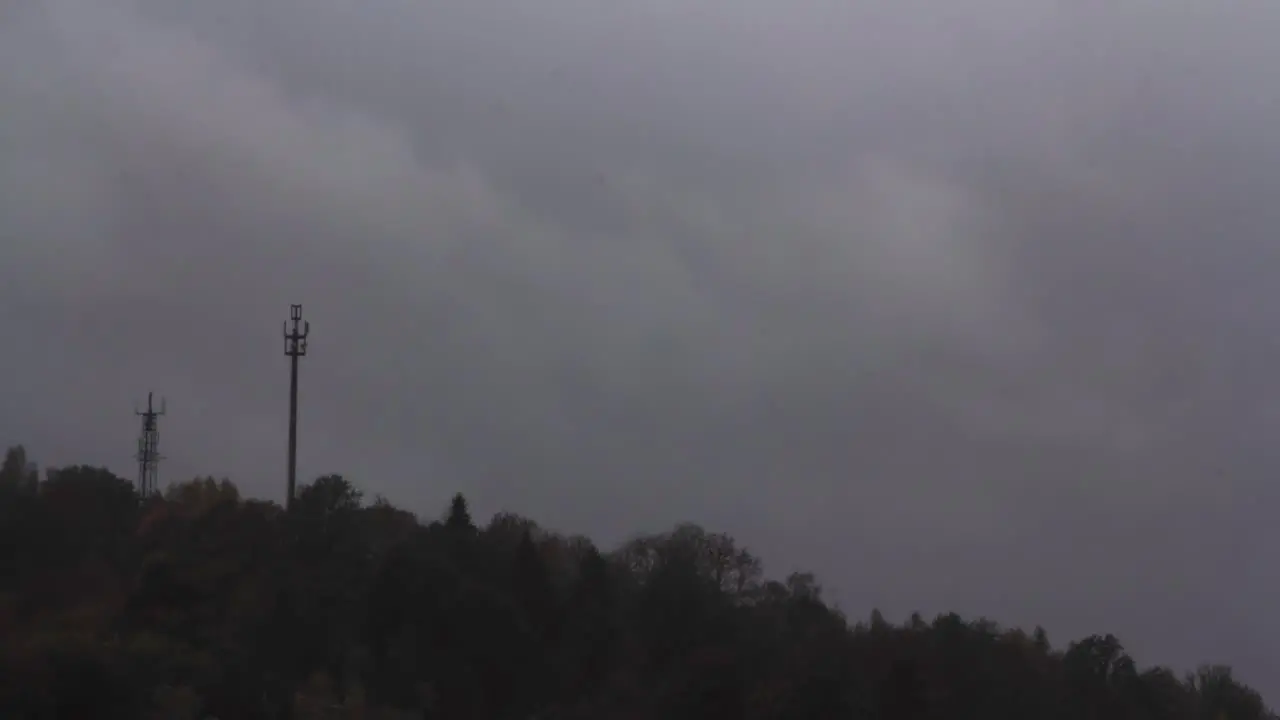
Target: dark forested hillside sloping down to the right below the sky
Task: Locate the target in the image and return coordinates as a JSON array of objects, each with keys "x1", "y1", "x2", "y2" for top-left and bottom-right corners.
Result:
[{"x1": 0, "y1": 447, "x2": 1276, "y2": 720}]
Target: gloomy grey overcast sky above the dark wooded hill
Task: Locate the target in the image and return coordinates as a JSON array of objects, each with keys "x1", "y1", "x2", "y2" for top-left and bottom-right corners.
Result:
[{"x1": 0, "y1": 0, "x2": 1280, "y2": 700}]
